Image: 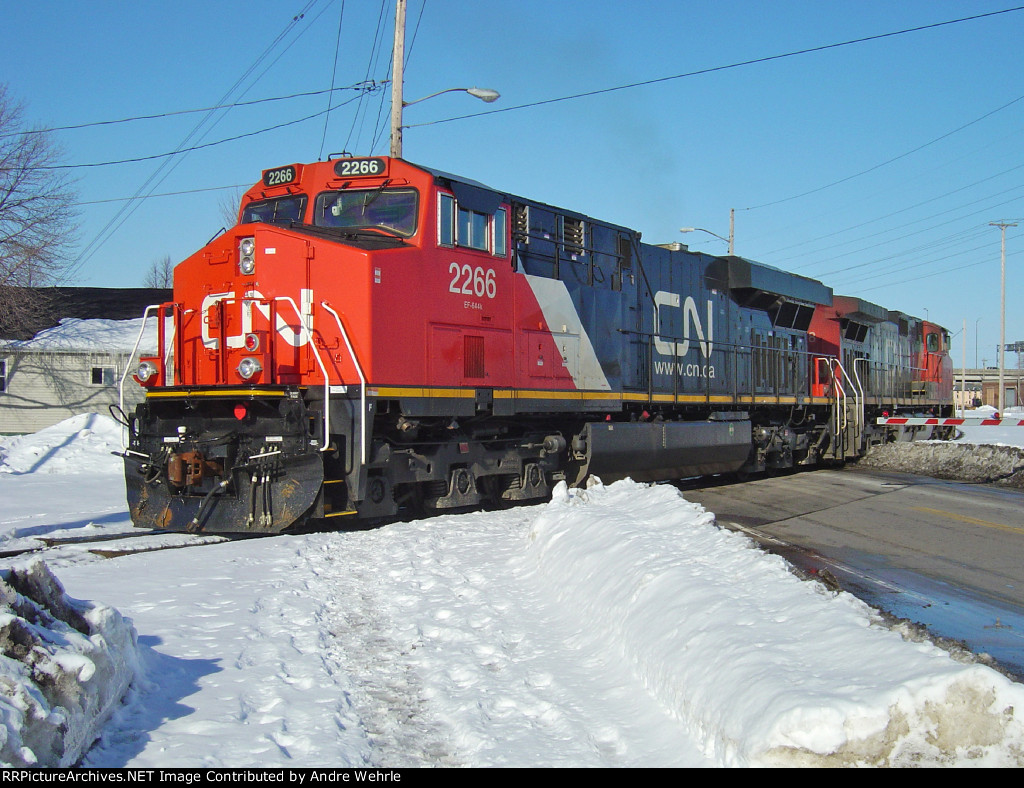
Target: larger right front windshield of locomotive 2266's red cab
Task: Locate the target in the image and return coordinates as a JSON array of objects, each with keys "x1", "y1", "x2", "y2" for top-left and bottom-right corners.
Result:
[{"x1": 313, "y1": 188, "x2": 418, "y2": 237}]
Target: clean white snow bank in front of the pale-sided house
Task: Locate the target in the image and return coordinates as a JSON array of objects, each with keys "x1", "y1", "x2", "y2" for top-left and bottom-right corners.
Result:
[{"x1": 0, "y1": 413, "x2": 124, "y2": 474}]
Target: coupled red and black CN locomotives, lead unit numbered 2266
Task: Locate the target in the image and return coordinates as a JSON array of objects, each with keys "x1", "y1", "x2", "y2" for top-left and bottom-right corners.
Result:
[{"x1": 125, "y1": 158, "x2": 951, "y2": 533}]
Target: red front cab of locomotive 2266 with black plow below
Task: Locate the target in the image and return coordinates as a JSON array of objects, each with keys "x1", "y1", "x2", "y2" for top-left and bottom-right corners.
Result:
[{"x1": 126, "y1": 159, "x2": 532, "y2": 532}]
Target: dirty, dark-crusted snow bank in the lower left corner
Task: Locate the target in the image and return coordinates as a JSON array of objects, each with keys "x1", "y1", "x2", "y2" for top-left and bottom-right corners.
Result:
[{"x1": 0, "y1": 561, "x2": 138, "y2": 767}]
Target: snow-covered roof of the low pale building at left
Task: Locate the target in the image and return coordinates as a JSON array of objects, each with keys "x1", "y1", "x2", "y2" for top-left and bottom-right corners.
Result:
[{"x1": 0, "y1": 317, "x2": 157, "y2": 354}]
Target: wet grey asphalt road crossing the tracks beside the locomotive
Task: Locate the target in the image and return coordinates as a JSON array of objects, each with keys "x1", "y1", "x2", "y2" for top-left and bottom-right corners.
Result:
[{"x1": 682, "y1": 469, "x2": 1024, "y2": 680}]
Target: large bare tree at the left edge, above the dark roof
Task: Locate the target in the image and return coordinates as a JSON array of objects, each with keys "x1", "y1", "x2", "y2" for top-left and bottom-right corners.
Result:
[{"x1": 0, "y1": 84, "x2": 77, "y2": 330}]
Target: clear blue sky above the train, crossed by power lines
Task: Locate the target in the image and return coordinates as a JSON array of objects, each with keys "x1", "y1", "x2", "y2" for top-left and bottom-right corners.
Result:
[{"x1": 8, "y1": 0, "x2": 1024, "y2": 366}]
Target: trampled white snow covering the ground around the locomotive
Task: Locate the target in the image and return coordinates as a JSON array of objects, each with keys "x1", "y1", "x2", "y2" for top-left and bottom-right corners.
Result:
[{"x1": 0, "y1": 417, "x2": 1024, "y2": 768}]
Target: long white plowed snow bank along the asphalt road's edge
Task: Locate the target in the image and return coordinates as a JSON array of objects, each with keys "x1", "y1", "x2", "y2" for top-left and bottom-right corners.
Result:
[{"x1": 528, "y1": 474, "x2": 1024, "y2": 765}]
